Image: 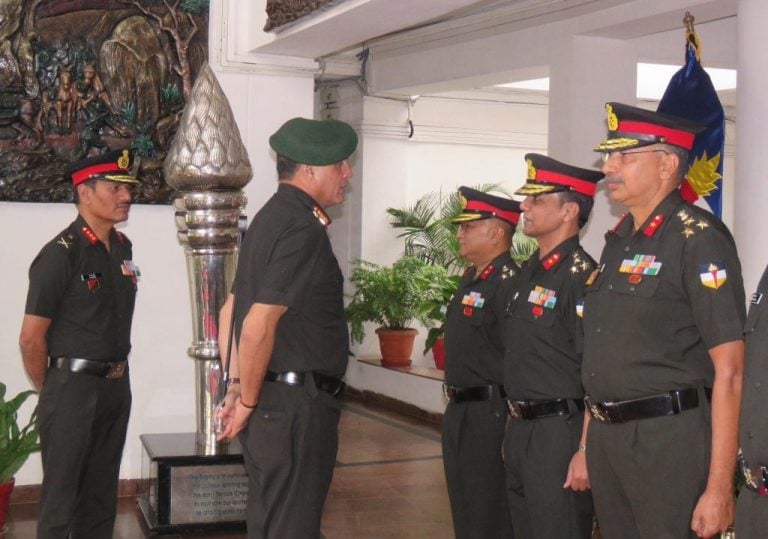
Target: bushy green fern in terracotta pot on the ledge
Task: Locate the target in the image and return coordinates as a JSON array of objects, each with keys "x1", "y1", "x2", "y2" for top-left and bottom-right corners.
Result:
[{"x1": 346, "y1": 256, "x2": 455, "y2": 342}]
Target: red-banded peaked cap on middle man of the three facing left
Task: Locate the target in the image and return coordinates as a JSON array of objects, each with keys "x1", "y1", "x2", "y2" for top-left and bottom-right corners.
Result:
[{"x1": 515, "y1": 153, "x2": 605, "y2": 197}]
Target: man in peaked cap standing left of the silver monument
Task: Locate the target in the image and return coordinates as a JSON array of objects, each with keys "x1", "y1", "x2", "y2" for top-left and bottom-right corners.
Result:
[{"x1": 19, "y1": 150, "x2": 140, "y2": 539}]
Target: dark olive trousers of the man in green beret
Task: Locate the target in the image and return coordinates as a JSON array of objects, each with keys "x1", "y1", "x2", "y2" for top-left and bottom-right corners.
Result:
[{"x1": 239, "y1": 377, "x2": 341, "y2": 539}]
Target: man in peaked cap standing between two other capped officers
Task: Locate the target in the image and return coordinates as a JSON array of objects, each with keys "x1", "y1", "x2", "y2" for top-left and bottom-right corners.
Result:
[{"x1": 504, "y1": 154, "x2": 603, "y2": 539}]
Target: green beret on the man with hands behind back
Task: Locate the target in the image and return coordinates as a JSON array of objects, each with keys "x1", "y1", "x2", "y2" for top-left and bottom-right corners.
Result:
[{"x1": 269, "y1": 118, "x2": 357, "y2": 166}]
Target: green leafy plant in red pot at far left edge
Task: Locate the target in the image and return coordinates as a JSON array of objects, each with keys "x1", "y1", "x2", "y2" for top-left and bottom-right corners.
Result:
[{"x1": 0, "y1": 382, "x2": 40, "y2": 484}]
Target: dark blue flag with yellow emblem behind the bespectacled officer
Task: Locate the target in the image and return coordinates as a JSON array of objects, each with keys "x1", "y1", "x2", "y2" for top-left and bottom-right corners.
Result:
[{"x1": 657, "y1": 22, "x2": 725, "y2": 217}]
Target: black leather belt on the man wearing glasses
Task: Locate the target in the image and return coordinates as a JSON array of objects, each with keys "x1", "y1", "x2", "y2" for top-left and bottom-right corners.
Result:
[{"x1": 584, "y1": 387, "x2": 699, "y2": 423}]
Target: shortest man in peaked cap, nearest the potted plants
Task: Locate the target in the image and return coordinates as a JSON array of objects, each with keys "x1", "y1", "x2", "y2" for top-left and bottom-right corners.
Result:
[{"x1": 442, "y1": 187, "x2": 520, "y2": 539}]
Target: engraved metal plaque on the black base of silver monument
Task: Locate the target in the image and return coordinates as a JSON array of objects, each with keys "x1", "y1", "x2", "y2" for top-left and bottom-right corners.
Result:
[{"x1": 170, "y1": 464, "x2": 248, "y2": 524}]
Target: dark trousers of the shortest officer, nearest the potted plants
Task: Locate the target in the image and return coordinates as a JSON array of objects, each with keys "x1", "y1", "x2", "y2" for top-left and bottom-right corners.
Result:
[{"x1": 443, "y1": 392, "x2": 512, "y2": 539}]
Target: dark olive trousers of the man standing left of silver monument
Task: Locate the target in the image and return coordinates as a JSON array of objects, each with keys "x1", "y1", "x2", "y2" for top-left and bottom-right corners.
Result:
[{"x1": 37, "y1": 369, "x2": 131, "y2": 539}]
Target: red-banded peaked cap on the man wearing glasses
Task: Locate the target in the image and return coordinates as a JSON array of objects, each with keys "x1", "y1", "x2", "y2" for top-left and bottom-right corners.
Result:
[{"x1": 595, "y1": 103, "x2": 704, "y2": 152}]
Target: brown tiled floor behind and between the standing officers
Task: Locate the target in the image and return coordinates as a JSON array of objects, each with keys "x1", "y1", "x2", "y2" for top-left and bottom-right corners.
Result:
[{"x1": 3, "y1": 402, "x2": 453, "y2": 539}]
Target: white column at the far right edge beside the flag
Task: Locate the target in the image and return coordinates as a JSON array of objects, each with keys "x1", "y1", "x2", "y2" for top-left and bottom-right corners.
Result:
[{"x1": 733, "y1": 0, "x2": 768, "y2": 297}]
